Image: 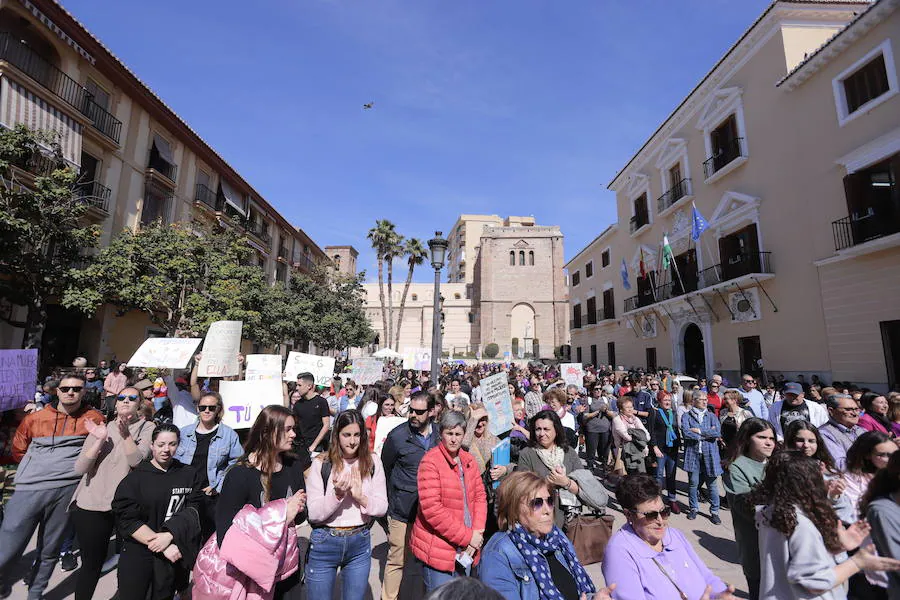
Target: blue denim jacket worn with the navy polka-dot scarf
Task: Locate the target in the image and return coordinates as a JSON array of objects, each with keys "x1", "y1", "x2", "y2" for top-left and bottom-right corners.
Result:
[{"x1": 478, "y1": 531, "x2": 575, "y2": 600}]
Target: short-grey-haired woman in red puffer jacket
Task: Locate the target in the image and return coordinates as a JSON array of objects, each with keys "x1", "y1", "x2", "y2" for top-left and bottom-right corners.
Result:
[{"x1": 409, "y1": 411, "x2": 487, "y2": 593}]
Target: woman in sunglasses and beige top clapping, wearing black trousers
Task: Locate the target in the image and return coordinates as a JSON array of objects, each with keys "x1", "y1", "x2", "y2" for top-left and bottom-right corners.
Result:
[{"x1": 69, "y1": 387, "x2": 156, "y2": 600}]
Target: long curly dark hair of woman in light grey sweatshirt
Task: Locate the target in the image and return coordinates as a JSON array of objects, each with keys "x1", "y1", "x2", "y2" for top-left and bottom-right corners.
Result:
[{"x1": 747, "y1": 450, "x2": 843, "y2": 553}]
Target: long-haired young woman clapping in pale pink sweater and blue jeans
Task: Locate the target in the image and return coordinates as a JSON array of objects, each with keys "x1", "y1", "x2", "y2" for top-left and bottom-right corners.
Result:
[{"x1": 306, "y1": 410, "x2": 387, "y2": 600}]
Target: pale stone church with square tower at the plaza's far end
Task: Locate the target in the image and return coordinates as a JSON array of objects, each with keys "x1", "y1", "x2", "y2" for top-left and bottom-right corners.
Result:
[{"x1": 357, "y1": 215, "x2": 568, "y2": 358}]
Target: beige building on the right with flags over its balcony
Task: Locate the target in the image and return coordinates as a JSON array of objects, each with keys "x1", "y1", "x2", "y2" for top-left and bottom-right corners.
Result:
[{"x1": 567, "y1": 0, "x2": 900, "y2": 389}]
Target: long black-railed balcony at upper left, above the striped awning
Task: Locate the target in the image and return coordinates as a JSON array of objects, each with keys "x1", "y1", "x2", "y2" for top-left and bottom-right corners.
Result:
[{"x1": 0, "y1": 31, "x2": 122, "y2": 144}]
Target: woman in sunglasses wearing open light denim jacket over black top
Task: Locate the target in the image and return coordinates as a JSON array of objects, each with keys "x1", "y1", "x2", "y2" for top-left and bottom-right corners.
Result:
[{"x1": 175, "y1": 392, "x2": 244, "y2": 542}]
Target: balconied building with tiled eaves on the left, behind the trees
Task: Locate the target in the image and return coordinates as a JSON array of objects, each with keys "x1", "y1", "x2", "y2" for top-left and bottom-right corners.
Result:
[{"x1": 0, "y1": 0, "x2": 326, "y2": 365}]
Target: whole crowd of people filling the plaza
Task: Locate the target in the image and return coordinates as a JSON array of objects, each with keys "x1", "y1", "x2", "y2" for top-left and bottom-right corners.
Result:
[{"x1": 0, "y1": 357, "x2": 900, "y2": 600}]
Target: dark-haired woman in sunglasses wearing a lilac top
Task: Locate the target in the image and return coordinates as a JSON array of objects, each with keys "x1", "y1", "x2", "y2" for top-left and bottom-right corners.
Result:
[{"x1": 603, "y1": 473, "x2": 734, "y2": 600}]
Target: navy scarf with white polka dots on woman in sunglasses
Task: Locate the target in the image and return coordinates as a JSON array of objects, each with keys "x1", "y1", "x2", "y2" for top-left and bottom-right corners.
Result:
[{"x1": 509, "y1": 523, "x2": 597, "y2": 600}]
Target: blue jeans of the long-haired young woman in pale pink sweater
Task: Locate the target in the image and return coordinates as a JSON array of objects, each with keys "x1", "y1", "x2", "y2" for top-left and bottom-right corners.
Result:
[{"x1": 306, "y1": 528, "x2": 372, "y2": 600}]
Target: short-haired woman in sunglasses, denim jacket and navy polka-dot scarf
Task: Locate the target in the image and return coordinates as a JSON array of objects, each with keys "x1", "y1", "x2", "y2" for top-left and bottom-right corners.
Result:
[{"x1": 479, "y1": 471, "x2": 612, "y2": 600}]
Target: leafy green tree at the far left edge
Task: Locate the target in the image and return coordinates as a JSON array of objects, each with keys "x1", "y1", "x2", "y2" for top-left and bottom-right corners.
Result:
[{"x1": 0, "y1": 125, "x2": 100, "y2": 348}]
